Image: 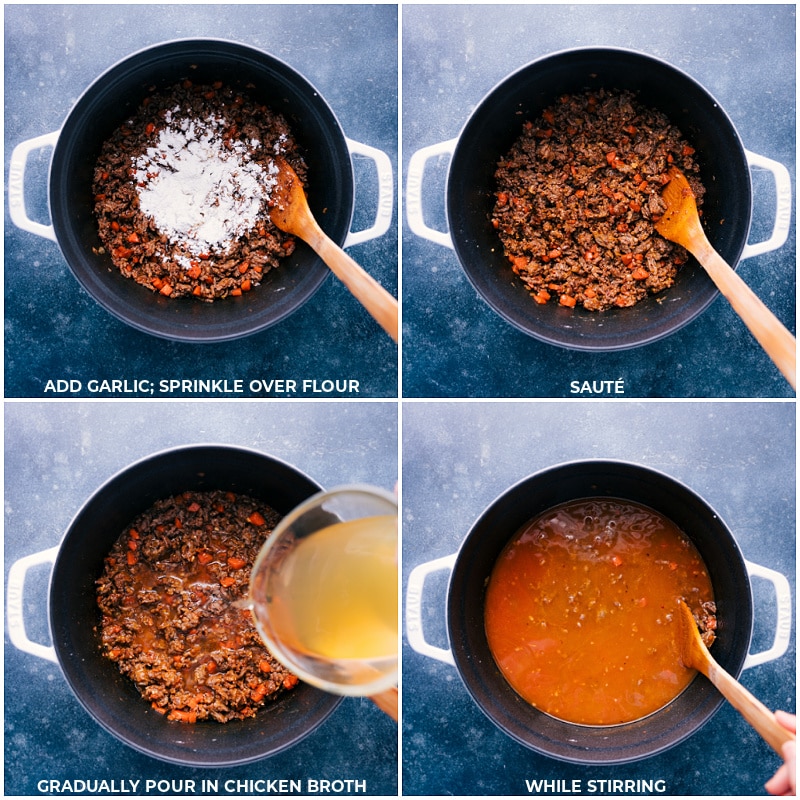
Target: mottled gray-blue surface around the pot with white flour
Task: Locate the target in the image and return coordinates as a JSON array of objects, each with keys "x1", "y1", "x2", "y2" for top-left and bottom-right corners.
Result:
[{"x1": 5, "y1": 4, "x2": 397, "y2": 397}]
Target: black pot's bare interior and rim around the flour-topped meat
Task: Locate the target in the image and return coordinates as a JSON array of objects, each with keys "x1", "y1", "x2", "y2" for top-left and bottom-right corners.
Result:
[{"x1": 37, "y1": 39, "x2": 354, "y2": 342}]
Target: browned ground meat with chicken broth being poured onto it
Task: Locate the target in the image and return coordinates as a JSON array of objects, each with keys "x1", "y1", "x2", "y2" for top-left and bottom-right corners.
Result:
[{"x1": 97, "y1": 491, "x2": 298, "y2": 722}]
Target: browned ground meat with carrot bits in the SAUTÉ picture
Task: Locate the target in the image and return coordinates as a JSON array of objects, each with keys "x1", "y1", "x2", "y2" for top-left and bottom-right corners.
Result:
[{"x1": 492, "y1": 90, "x2": 704, "y2": 311}]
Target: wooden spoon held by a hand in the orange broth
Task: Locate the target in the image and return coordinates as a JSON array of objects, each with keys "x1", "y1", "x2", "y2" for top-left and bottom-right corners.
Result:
[{"x1": 678, "y1": 600, "x2": 795, "y2": 757}]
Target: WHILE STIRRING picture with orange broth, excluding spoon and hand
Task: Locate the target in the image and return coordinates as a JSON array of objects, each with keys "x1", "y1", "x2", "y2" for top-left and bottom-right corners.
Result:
[{"x1": 402, "y1": 401, "x2": 797, "y2": 797}]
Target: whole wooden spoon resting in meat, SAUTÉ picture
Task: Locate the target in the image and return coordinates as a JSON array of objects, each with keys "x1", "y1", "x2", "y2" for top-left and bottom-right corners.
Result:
[{"x1": 656, "y1": 167, "x2": 796, "y2": 389}]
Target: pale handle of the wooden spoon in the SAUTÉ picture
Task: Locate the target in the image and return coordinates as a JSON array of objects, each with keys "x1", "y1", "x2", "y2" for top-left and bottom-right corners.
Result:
[{"x1": 695, "y1": 241, "x2": 797, "y2": 389}]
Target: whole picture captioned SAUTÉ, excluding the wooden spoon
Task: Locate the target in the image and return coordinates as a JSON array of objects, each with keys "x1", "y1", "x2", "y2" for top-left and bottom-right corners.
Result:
[{"x1": 402, "y1": 3, "x2": 796, "y2": 399}]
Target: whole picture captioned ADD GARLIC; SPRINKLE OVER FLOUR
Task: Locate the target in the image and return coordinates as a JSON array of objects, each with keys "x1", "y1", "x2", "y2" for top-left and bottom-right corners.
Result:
[{"x1": 4, "y1": 3, "x2": 398, "y2": 399}]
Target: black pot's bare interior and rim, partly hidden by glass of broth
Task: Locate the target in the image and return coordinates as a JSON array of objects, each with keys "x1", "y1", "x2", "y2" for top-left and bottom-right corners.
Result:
[{"x1": 22, "y1": 445, "x2": 342, "y2": 767}]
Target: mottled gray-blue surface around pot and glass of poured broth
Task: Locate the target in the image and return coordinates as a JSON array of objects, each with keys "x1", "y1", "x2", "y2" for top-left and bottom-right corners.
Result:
[{"x1": 4, "y1": 401, "x2": 397, "y2": 795}]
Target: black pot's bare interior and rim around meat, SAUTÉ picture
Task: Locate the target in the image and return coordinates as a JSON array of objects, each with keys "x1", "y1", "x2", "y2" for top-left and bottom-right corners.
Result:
[{"x1": 428, "y1": 48, "x2": 780, "y2": 350}]
